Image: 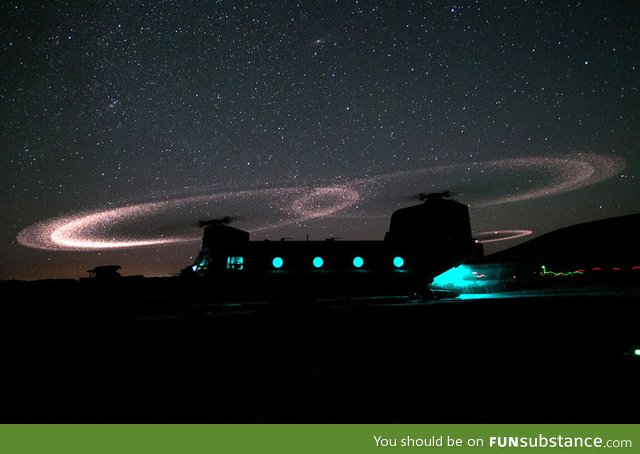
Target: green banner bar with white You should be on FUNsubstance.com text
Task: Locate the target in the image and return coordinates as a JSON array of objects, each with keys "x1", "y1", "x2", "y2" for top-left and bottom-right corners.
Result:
[{"x1": 0, "y1": 424, "x2": 640, "y2": 454}]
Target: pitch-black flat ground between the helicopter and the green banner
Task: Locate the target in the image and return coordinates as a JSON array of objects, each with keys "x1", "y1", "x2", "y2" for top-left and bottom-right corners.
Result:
[{"x1": 0, "y1": 281, "x2": 640, "y2": 423}]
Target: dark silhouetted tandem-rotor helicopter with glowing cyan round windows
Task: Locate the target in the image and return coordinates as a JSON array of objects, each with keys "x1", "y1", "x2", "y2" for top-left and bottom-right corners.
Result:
[{"x1": 181, "y1": 191, "x2": 482, "y2": 298}]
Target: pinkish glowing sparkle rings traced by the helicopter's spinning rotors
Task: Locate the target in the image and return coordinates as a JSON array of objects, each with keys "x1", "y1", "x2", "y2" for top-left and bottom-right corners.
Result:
[{"x1": 18, "y1": 154, "x2": 624, "y2": 250}]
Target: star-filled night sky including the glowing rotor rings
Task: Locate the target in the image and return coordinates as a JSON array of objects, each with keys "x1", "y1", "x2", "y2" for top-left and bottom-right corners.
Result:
[{"x1": 0, "y1": 0, "x2": 640, "y2": 279}]
